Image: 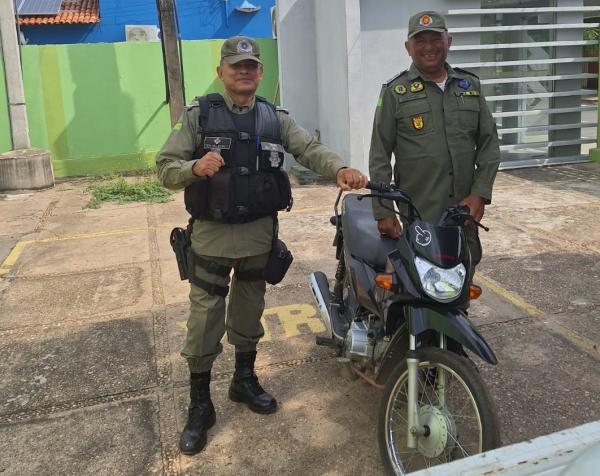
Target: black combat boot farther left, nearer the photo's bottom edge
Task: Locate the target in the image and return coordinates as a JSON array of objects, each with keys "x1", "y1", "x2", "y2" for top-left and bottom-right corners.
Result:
[{"x1": 179, "y1": 372, "x2": 216, "y2": 455}]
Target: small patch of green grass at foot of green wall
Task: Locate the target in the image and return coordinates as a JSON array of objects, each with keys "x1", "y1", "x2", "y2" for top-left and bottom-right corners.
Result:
[{"x1": 84, "y1": 177, "x2": 173, "y2": 208}]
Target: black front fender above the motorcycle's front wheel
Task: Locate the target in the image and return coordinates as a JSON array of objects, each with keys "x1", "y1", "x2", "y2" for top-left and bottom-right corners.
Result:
[{"x1": 406, "y1": 306, "x2": 498, "y2": 365}]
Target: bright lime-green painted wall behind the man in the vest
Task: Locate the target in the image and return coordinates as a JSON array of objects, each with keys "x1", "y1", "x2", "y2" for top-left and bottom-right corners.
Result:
[{"x1": 0, "y1": 39, "x2": 278, "y2": 177}]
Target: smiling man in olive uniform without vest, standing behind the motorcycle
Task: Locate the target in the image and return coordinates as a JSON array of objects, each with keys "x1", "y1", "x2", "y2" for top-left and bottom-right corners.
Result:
[{"x1": 369, "y1": 11, "x2": 500, "y2": 274}]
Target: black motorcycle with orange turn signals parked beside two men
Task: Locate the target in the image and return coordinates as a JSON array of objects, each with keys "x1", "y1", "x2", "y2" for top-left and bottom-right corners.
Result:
[{"x1": 310, "y1": 182, "x2": 500, "y2": 475}]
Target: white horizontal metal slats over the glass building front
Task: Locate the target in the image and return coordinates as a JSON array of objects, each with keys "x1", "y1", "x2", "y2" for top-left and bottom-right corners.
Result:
[{"x1": 447, "y1": 0, "x2": 600, "y2": 169}]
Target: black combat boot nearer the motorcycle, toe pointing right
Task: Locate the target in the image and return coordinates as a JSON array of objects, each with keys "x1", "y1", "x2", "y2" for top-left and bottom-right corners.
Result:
[{"x1": 229, "y1": 351, "x2": 277, "y2": 414}]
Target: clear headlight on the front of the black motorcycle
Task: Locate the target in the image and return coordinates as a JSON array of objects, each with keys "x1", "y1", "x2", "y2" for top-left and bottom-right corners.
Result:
[{"x1": 415, "y1": 256, "x2": 467, "y2": 302}]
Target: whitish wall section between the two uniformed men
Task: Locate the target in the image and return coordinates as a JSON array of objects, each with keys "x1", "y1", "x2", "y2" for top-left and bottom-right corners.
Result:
[{"x1": 277, "y1": 0, "x2": 363, "y2": 169}]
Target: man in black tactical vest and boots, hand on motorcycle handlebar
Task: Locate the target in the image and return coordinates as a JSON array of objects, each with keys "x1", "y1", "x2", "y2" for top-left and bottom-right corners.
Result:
[{"x1": 157, "y1": 36, "x2": 367, "y2": 454}]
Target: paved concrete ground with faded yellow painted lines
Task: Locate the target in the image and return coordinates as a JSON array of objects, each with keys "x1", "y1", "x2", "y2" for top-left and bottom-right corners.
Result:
[{"x1": 0, "y1": 163, "x2": 600, "y2": 476}]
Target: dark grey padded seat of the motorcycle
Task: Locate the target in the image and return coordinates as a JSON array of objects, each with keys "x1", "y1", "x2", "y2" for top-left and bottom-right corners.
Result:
[{"x1": 342, "y1": 193, "x2": 397, "y2": 271}]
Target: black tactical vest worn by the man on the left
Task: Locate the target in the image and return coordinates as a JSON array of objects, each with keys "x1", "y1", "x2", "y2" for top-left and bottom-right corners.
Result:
[{"x1": 184, "y1": 94, "x2": 292, "y2": 223}]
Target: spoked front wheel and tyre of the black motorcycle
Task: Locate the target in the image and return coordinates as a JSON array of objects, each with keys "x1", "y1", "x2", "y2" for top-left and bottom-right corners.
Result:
[{"x1": 377, "y1": 347, "x2": 500, "y2": 475}]
